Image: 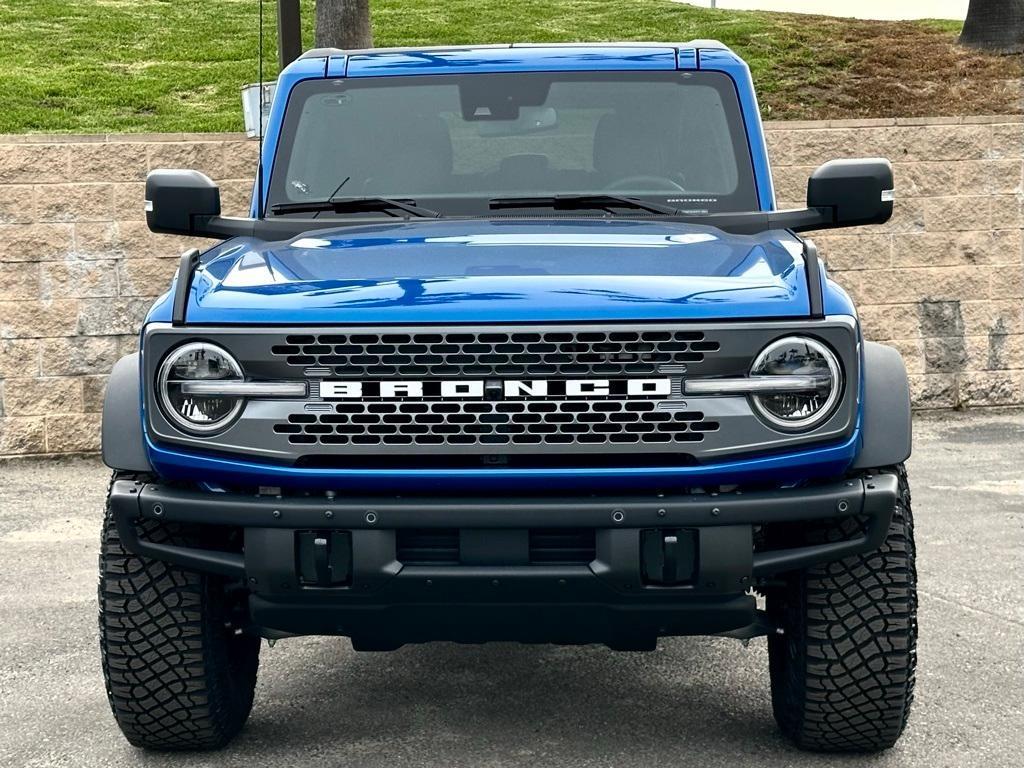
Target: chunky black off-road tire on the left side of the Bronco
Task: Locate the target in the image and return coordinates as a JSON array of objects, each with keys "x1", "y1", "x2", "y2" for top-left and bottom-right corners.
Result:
[{"x1": 99, "y1": 472, "x2": 259, "y2": 750}]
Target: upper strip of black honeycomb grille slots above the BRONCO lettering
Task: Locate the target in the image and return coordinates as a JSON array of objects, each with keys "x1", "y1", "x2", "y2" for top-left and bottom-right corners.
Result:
[{"x1": 270, "y1": 330, "x2": 719, "y2": 378}]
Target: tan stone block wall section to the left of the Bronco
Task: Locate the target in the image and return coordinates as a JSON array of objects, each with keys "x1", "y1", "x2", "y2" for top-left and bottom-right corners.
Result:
[{"x1": 0, "y1": 134, "x2": 257, "y2": 459}]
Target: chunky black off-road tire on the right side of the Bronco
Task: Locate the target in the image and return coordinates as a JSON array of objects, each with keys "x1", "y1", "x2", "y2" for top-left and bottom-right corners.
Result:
[{"x1": 768, "y1": 465, "x2": 918, "y2": 752}]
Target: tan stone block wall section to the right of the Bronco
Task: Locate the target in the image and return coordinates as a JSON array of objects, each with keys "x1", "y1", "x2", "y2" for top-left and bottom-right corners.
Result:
[{"x1": 768, "y1": 118, "x2": 1024, "y2": 409}]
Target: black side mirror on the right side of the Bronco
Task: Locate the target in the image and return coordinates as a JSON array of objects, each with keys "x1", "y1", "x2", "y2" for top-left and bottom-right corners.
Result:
[{"x1": 807, "y1": 158, "x2": 894, "y2": 226}]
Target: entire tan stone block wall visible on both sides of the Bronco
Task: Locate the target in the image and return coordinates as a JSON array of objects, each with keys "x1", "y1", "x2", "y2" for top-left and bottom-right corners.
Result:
[{"x1": 0, "y1": 117, "x2": 1024, "y2": 459}]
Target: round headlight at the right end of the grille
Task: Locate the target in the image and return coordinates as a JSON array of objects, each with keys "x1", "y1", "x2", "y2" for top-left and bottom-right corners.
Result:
[{"x1": 751, "y1": 336, "x2": 843, "y2": 431}]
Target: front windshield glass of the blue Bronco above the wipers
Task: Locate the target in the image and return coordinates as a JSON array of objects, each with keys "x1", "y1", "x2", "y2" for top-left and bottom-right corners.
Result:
[{"x1": 268, "y1": 72, "x2": 758, "y2": 216}]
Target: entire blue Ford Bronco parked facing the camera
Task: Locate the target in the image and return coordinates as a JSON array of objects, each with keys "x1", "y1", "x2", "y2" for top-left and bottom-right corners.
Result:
[{"x1": 99, "y1": 41, "x2": 916, "y2": 751}]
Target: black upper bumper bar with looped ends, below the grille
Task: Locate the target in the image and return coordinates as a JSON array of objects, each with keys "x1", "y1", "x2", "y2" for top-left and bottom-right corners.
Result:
[{"x1": 112, "y1": 474, "x2": 897, "y2": 575}]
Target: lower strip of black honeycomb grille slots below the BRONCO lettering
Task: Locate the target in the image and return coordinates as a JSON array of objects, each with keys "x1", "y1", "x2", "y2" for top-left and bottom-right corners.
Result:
[{"x1": 273, "y1": 399, "x2": 719, "y2": 446}]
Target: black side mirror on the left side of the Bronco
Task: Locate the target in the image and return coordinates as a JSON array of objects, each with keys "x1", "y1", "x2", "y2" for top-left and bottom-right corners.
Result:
[{"x1": 145, "y1": 170, "x2": 220, "y2": 236}]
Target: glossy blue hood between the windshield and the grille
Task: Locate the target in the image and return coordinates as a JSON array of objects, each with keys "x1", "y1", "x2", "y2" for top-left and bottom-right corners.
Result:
[{"x1": 161, "y1": 218, "x2": 809, "y2": 325}]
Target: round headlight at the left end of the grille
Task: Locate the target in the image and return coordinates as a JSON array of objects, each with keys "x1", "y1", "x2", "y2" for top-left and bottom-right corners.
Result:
[{"x1": 157, "y1": 341, "x2": 243, "y2": 434}]
